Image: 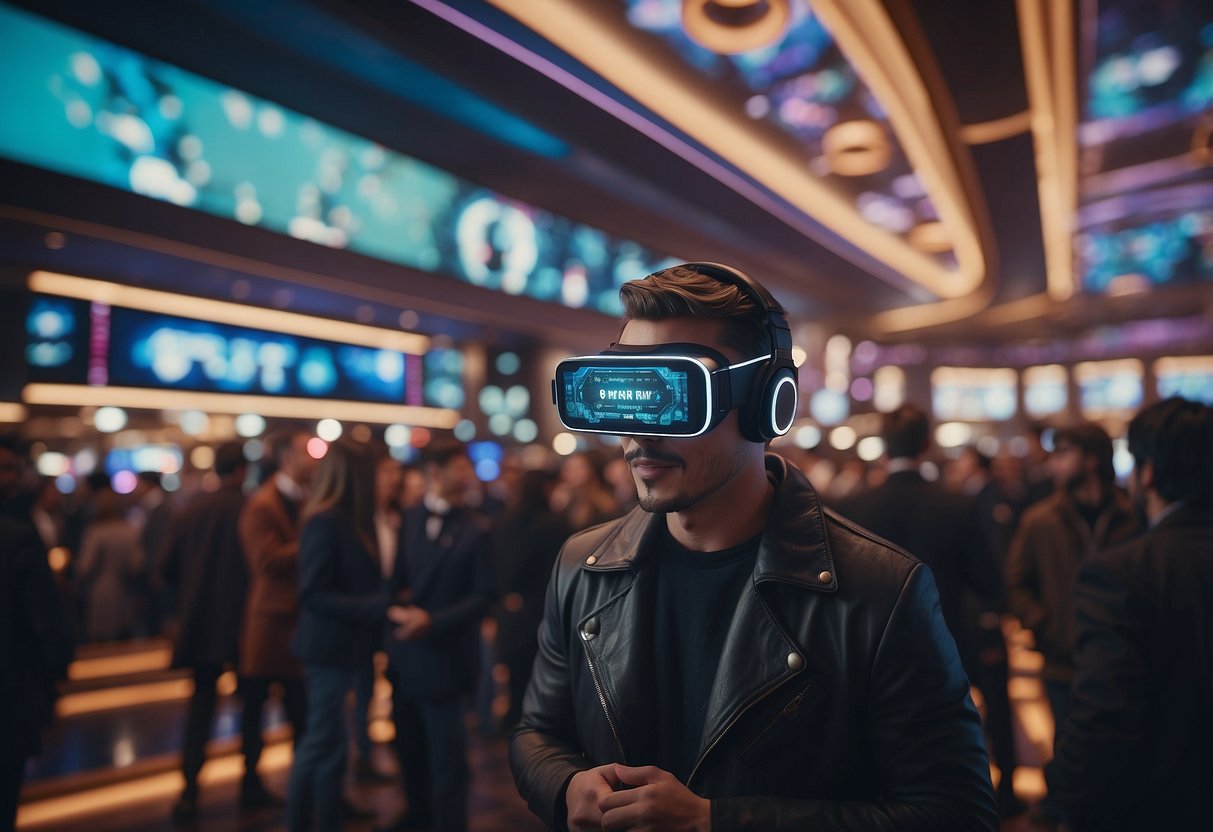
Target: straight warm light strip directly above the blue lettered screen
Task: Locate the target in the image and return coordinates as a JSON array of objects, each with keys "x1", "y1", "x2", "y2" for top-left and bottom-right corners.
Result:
[{"x1": 28, "y1": 270, "x2": 429, "y2": 355}]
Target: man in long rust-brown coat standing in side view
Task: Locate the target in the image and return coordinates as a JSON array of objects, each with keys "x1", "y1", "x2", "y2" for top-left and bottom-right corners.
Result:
[{"x1": 239, "y1": 431, "x2": 315, "y2": 808}]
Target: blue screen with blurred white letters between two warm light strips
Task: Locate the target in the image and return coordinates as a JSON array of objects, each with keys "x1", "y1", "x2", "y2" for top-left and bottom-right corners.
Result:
[{"x1": 25, "y1": 296, "x2": 443, "y2": 406}]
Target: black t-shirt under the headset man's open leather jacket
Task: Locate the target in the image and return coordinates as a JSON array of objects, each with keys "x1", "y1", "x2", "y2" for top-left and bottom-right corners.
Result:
[{"x1": 654, "y1": 523, "x2": 762, "y2": 782}]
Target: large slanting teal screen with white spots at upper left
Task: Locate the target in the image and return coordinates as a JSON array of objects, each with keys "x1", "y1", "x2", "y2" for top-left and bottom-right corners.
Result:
[{"x1": 0, "y1": 4, "x2": 676, "y2": 314}]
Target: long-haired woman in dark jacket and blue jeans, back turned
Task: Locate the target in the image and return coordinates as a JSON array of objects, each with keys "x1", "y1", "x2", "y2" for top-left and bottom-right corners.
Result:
[{"x1": 286, "y1": 439, "x2": 389, "y2": 832}]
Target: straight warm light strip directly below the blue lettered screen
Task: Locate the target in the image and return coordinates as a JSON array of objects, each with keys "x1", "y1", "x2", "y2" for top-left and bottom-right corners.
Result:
[{"x1": 22, "y1": 383, "x2": 460, "y2": 431}]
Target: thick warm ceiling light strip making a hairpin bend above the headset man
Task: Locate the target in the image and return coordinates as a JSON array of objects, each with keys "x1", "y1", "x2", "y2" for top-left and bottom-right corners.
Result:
[{"x1": 477, "y1": 0, "x2": 985, "y2": 303}]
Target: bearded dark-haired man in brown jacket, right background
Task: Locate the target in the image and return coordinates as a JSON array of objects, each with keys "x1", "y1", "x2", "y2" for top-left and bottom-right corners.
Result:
[{"x1": 1007, "y1": 422, "x2": 1140, "y2": 822}]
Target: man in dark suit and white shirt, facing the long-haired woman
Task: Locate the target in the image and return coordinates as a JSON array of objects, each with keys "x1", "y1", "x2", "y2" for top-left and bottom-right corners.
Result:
[{"x1": 376, "y1": 439, "x2": 494, "y2": 832}]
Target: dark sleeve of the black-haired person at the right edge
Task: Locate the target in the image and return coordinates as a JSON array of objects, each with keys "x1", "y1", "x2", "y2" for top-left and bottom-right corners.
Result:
[{"x1": 1048, "y1": 550, "x2": 1152, "y2": 832}]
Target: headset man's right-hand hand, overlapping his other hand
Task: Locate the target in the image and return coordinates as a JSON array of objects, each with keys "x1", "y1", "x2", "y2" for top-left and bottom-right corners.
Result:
[{"x1": 599, "y1": 765, "x2": 712, "y2": 832}]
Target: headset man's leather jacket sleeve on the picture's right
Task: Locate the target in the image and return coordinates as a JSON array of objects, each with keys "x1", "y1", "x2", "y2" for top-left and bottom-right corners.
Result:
[{"x1": 712, "y1": 564, "x2": 998, "y2": 832}]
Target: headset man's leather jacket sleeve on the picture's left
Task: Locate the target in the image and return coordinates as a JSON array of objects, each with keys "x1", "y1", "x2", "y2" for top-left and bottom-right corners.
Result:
[{"x1": 509, "y1": 543, "x2": 591, "y2": 830}]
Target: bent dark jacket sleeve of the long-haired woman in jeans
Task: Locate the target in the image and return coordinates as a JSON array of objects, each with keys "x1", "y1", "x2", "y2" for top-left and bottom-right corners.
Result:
[{"x1": 300, "y1": 514, "x2": 388, "y2": 622}]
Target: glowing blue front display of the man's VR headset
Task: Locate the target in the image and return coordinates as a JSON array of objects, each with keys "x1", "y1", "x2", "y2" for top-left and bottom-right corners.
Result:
[{"x1": 556, "y1": 357, "x2": 710, "y2": 435}]
